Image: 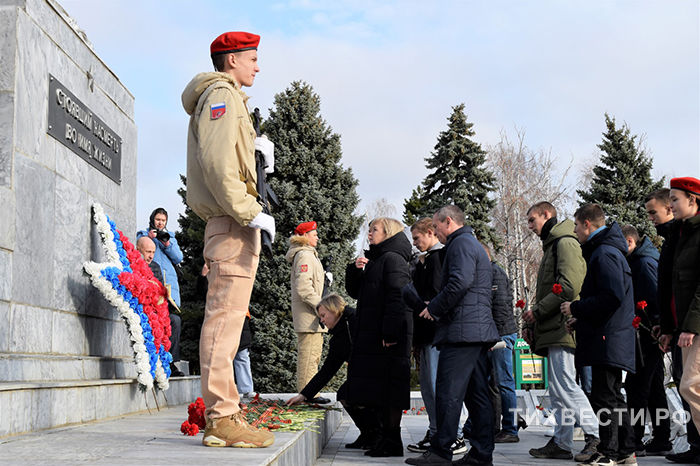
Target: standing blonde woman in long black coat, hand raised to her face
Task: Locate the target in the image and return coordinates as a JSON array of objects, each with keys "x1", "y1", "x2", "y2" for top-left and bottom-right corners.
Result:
[{"x1": 345, "y1": 217, "x2": 413, "y2": 456}]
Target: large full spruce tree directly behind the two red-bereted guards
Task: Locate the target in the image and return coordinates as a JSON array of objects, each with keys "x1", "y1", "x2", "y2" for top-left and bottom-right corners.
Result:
[{"x1": 251, "y1": 81, "x2": 361, "y2": 392}]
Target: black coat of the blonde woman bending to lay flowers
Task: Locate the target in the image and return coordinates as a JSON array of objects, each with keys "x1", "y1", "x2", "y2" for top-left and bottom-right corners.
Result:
[{"x1": 301, "y1": 306, "x2": 357, "y2": 400}]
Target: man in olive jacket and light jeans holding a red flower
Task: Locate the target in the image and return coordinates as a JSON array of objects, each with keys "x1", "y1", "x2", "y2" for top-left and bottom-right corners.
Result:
[{"x1": 522, "y1": 201, "x2": 598, "y2": 461}]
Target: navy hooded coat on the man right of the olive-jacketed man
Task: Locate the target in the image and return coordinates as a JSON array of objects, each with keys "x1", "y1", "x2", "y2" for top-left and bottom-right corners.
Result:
[{"x1": 571, "y1": 222, "x2": 636, "y2": 373}]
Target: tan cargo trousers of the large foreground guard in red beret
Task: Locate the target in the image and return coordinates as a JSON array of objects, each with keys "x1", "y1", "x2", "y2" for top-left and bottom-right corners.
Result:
[{"x1": 199, "y1": 216, "x2": 260, "y2": 418}]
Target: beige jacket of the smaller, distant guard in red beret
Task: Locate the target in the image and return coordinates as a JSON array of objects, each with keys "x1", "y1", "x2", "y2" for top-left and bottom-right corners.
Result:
[{"x1": 285, "y1": 235, "x2": 327, "y2": 333}]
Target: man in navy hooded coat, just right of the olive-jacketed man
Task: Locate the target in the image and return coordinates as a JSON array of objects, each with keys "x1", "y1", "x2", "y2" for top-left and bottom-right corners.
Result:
[{"x1": 561, "y1": 204, "x2": 637, "y2": 465}]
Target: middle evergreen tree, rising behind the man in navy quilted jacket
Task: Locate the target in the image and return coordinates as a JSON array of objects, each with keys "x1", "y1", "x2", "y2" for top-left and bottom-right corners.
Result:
[{"x1": 404, "y1": 104, "x2": 500, "y2": 248}]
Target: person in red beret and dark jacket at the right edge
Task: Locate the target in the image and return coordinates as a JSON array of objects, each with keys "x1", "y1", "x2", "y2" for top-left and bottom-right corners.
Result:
[{"x1": 660, "y1": 177, "x2": 700, "y2": 462}]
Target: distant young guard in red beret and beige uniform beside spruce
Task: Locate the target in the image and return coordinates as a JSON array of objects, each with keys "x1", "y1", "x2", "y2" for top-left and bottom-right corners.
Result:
[{"x1": 285, "y1": 221, "x2": 330, "y2": 403}]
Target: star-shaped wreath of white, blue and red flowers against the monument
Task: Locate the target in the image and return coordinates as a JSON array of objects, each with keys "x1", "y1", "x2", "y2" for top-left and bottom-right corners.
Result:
[{"x1": 83, "y1": 203, "x2": 173, "y2": 391}]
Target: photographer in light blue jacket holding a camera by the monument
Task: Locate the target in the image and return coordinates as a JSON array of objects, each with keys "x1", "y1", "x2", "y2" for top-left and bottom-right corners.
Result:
[{"x1": 136, "y1": 207, "x2": 182, "y2": 376}]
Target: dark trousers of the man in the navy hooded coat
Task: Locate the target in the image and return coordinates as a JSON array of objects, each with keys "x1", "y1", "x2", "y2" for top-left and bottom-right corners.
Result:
[{"x1": 591, "y1": 365, "x2": 635, "y2": 460}]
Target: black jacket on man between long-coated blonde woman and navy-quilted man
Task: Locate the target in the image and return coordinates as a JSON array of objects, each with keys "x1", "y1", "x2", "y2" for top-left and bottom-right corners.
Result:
[{"x1": 413, "y1": 244, "x2": 442, "y2": 346}]
